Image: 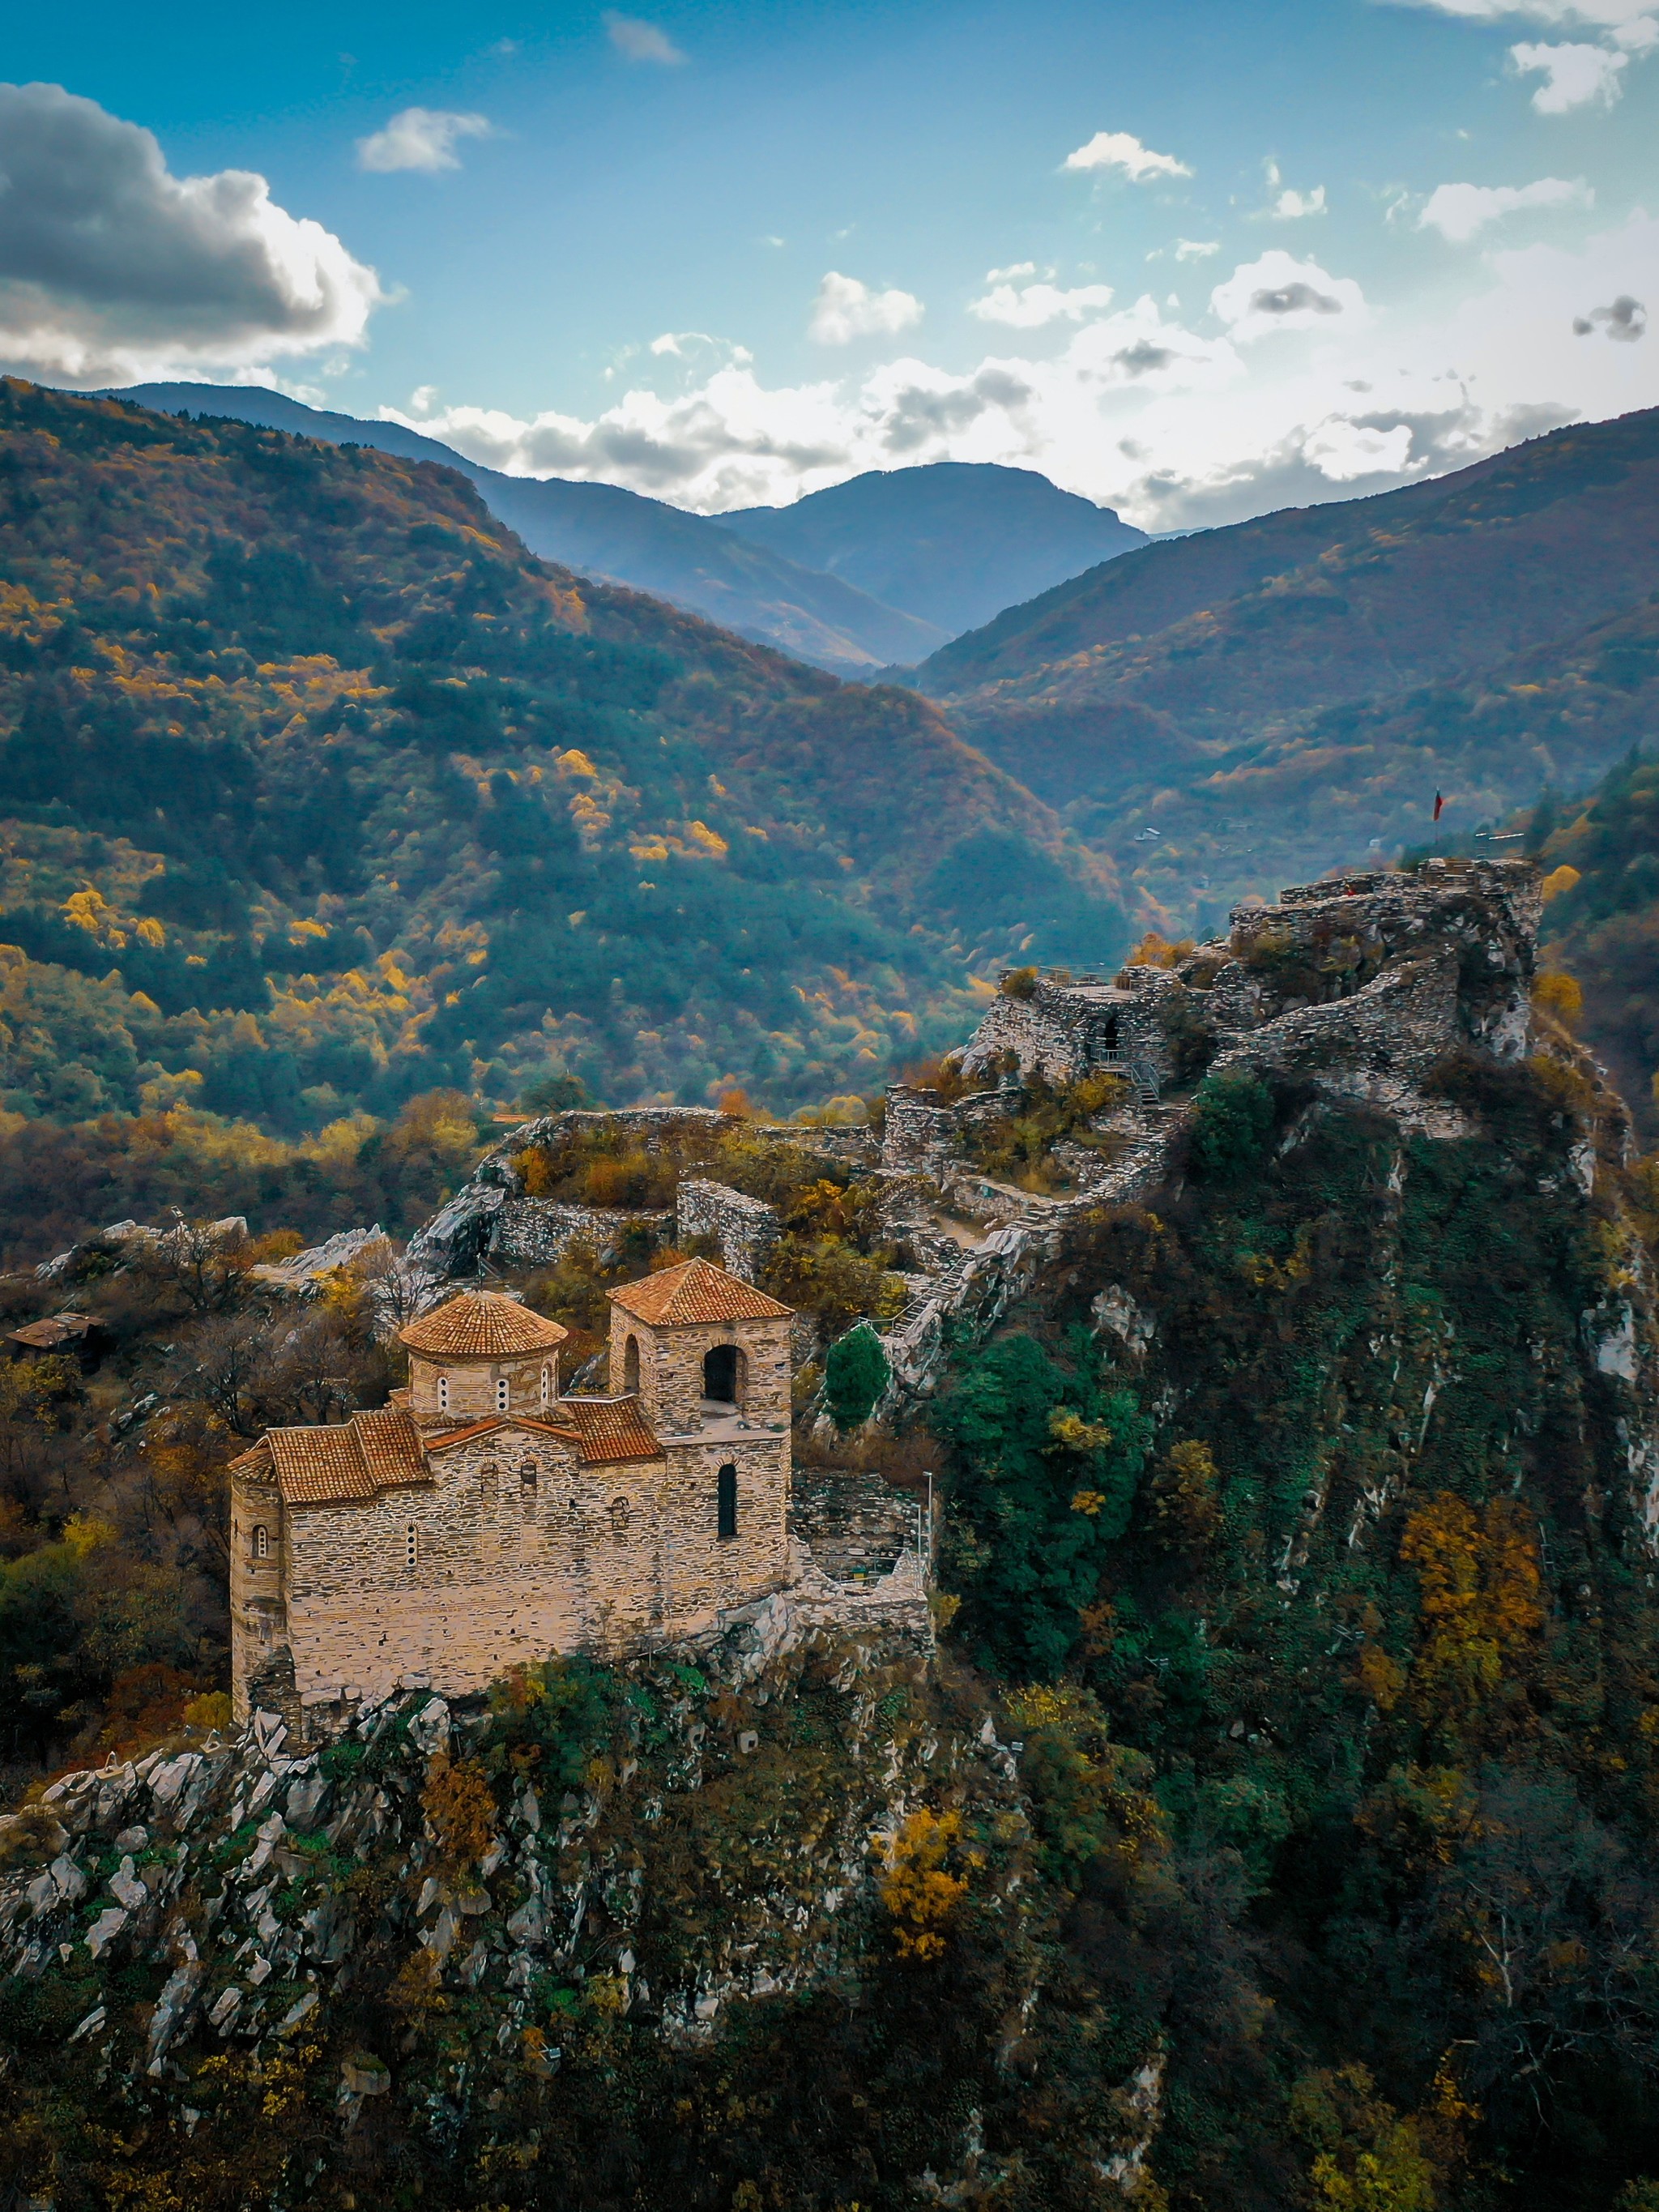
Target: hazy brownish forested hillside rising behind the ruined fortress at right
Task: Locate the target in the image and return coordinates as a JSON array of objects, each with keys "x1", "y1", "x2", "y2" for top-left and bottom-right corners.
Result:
[{"x1": 918, "y1": 412, "x2": 1659, "y2": 918}]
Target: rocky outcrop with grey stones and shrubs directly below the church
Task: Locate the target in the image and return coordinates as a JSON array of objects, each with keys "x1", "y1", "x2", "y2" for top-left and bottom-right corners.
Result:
[{"x1": 0, "y1": 1617, "x2": 1157, "y2": 2212}]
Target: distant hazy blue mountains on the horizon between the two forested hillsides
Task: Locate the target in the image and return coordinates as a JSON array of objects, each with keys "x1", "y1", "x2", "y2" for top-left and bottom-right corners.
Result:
[{"x1": 111, "y1": 382, "x2": 1144, "y2": 677}]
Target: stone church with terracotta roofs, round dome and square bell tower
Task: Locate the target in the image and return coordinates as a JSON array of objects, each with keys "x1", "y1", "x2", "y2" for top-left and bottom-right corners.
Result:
[{"x1": 230, "y1": 1258, "x2": 792, "y2": 1723}]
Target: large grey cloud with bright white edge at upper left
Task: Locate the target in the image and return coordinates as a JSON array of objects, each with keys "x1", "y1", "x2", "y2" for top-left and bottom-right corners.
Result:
[{"x1": 0, "y1": 84, "x2": 385, "y2": 385}]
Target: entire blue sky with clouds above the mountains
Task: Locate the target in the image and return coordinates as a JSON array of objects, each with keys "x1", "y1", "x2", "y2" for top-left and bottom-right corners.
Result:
[{"x1": 0, "y1": 0, "x2": 1659, "y2": 528}]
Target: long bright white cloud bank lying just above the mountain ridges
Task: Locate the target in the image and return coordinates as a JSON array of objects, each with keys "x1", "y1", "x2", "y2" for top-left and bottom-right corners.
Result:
[{"x1": 387, "y1": 215, "x2": 1659, "y2": 528}]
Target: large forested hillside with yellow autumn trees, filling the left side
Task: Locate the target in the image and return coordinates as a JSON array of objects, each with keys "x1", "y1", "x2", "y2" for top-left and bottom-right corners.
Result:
[{"x1": 0, "y1": 382, "x2": 1124, "y2": 1130}]
